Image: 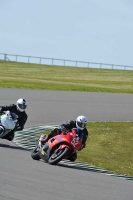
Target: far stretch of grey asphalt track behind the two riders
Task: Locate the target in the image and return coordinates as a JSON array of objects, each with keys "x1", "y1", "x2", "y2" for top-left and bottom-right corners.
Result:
[{"x1": 0, "y1": 88, "x2": 133, "y2": 125}]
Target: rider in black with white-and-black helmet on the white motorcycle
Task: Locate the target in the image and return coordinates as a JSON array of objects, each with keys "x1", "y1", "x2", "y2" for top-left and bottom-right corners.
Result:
[{"x1": 0, "y1": 98, "x2": 28, "y2": 141}]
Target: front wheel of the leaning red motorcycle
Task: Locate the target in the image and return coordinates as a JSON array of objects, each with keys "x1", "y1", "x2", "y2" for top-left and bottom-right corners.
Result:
[{"x1": 48, "y1": 147, "x2": 70, "y2": 165}]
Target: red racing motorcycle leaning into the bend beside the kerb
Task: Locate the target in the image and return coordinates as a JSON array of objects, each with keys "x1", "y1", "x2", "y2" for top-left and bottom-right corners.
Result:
[{"x1": 31, "y1": 128, "x2": 83, "y2": 165}]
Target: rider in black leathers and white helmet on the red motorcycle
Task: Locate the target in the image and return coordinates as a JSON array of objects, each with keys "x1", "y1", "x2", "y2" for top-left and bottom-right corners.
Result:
[{"x1": 39, "y1": 115, "x2": 89, "y2": 161}]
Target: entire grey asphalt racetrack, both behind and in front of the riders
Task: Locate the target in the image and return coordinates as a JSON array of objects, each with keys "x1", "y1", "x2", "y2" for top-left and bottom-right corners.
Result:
[{"x1": 0, "y1": 88, "x2": 133, "y2": 200}]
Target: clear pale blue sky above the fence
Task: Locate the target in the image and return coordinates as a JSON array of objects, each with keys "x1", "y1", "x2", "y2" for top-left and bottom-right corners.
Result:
[{"x1": 0, "y1": 0, "x2": 133, "y2": 66}]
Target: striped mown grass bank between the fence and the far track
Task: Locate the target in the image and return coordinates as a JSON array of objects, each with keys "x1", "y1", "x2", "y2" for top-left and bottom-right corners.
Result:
[{"x1": 0, "y1": 61, "x2": 133, "y2": 93}]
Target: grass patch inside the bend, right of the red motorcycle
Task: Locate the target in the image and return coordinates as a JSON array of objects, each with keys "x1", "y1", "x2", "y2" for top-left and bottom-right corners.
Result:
[{"x1": 78, "y1": 122, "x2": 133, "y2": 176}]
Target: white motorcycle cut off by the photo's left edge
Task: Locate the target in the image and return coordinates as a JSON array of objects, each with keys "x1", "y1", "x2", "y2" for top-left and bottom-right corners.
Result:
[{"x1": 0, "y1": 110, "x2": 18, "y2": 138}]
